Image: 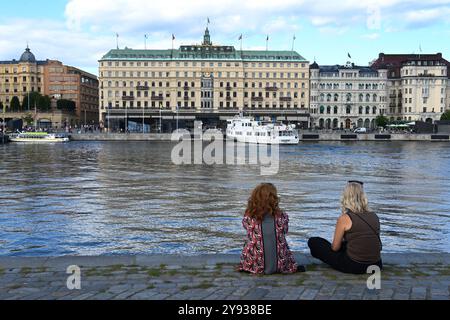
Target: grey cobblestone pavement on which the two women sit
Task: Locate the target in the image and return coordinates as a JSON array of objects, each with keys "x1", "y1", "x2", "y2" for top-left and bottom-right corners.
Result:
[{"x1": 0, "y1": 254, "x2": 450, "y2": 300}]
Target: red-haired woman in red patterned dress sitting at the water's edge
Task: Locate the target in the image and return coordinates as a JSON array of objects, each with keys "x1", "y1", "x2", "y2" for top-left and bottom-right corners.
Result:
[{"x1": 238, "y1": 183, "x2": 304, "y2": 274}]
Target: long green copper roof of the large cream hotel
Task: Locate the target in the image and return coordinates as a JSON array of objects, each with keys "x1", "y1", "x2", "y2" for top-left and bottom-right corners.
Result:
[{"x1": 100, "y1": 45, "x2": 306, "y2": 62}]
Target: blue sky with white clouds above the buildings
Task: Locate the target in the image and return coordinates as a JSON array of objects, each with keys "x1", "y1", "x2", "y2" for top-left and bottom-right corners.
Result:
[{"x1": 0, "y1": 0, "x2": 450, "y2": 74}]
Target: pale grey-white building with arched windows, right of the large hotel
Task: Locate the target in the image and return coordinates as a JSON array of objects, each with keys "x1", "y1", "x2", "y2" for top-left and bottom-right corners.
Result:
[{"x1": 310, "y1": 62, "x2": 387, "y2": 129}]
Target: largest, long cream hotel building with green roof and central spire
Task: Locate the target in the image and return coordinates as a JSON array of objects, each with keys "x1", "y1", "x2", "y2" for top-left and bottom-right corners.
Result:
[{"x1": 99, "y1": 28, "x2": 309, "y2": 131}]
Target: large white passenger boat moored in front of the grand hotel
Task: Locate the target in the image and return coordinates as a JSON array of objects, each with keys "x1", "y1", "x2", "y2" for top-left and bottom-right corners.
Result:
[{"x1": 227, "y1": 116, "x2": 299, "y2": 144}]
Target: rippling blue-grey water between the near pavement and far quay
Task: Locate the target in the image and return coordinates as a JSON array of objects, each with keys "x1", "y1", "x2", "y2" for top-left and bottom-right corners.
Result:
[{"x1": 0, "y1": 142, "x2": 450, "y2": 256}]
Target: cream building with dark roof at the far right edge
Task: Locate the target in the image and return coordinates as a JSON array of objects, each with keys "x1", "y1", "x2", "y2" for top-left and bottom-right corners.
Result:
[{"x1": 372, "y1": 53, "x2": 450, "y2": 122}]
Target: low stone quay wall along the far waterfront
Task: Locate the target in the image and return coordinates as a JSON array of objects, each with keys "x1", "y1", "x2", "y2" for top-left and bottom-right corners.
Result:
[{"x1": 70, "y1": 133, "x2": 450, "y2": 142}]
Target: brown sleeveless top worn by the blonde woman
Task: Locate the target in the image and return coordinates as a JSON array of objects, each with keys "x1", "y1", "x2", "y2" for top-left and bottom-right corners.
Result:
[{"x1": 344, "y1": 210, "x2": 382, "y2": 263}]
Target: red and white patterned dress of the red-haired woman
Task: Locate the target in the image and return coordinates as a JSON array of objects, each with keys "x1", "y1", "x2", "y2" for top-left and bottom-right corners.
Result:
[{"x1": 239, "y1": 211, "x2": 297, "y2": 274}]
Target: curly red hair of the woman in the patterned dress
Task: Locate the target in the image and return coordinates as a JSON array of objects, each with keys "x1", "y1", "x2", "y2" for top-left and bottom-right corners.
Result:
[{"x1": 245, "y1": 183, "x2": 280, "y2": 221}]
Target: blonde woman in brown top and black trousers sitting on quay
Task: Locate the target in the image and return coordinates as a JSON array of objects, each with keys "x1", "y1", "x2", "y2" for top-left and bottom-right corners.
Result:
[{"x1": 308, "y1": 181, "x2": 382, "y2": 274}]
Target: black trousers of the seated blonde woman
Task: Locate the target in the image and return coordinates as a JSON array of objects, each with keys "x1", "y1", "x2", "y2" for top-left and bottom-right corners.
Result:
[{"x1": 308, "y1": 238, "x2": 383, "y2": 274}]
